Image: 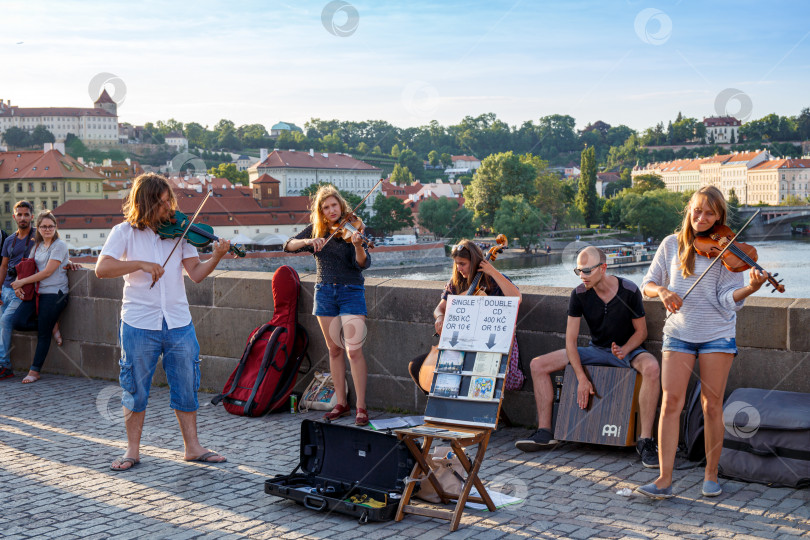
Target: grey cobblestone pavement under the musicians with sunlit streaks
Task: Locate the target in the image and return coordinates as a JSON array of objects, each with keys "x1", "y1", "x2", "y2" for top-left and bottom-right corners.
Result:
[{"x1": 0, "y1": 375, "x2": 810, "y2": 540}]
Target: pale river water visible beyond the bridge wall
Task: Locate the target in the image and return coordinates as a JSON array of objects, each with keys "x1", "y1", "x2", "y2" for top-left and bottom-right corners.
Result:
[{"x1": 364, "y1": 237, "x2": 810, "y2": 298}]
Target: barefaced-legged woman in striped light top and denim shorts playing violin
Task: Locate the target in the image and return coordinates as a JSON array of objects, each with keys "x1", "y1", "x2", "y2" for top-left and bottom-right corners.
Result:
[{"x1": 636, "y1": 186, "x2": 768, "y2": 499}]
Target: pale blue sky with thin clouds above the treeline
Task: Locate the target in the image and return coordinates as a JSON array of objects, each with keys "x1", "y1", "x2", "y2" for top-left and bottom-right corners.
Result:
[{"x1": 0, "y1": 0, "x2": 810, "y2": 130}]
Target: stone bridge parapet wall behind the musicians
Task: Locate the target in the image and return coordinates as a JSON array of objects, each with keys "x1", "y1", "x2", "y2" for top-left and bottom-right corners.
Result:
[{"x1": 7, "y1": 269, "x2": 810, "y2": 425}]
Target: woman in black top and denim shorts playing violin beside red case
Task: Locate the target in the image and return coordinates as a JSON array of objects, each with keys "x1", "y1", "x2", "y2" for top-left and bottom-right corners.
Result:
[{"x1": 284, "y1": 185, "x2": 371, "y2": 426}]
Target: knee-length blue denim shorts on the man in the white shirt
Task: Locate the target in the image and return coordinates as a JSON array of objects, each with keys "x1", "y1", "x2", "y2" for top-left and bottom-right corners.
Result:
[{"x1": 118, "y1": 319, "x2": 200, "y2": 412}]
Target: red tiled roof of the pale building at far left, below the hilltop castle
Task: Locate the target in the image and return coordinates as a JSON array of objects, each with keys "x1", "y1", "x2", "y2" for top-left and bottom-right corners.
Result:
[{"x1": 0, "y1": 150, "x2": 104, "y2": 180}]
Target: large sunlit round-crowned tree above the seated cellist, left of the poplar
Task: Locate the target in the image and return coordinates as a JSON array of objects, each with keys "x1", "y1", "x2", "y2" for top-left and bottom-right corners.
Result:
[{"x1": 464, "y1": 151, "x2": 537, "y2": 227}]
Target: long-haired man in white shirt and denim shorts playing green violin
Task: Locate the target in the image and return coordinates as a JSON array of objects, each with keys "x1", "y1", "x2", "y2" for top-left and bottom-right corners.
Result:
[{"x1": 96, "y1": 173, "x2": 230, "y2": 471}]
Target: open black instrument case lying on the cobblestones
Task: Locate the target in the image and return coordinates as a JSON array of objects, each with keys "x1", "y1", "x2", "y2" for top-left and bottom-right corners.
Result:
[{"x1": 264, "y1": 420, "x2": 414, "y2": 523}]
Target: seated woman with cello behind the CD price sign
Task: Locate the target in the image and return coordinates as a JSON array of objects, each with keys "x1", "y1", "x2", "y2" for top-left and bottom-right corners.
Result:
[{"x1": 408, "y1": 238, "x2": 523, "y2": 393}]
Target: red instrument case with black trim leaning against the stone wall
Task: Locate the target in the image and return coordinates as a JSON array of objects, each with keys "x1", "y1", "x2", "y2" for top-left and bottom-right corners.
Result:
[{"x1": 211, "y1": 266, "x2": 311, "y2": 416}]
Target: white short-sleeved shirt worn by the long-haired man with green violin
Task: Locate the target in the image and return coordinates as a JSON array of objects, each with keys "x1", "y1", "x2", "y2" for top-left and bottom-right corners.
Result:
[{"x1": 99, "y1": 222, "x2": 198, "y2": 330}]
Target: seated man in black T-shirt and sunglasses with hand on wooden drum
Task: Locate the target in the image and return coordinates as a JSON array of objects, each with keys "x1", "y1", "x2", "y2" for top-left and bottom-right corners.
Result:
[{"x1": 515, "y1": 246, "x2": 659, "y2": 468}]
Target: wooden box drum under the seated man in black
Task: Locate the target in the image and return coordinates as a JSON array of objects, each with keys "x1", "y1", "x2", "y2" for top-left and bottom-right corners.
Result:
[{"x1": 554, "y1": 365, "x2": 641, "y2": 446}]
